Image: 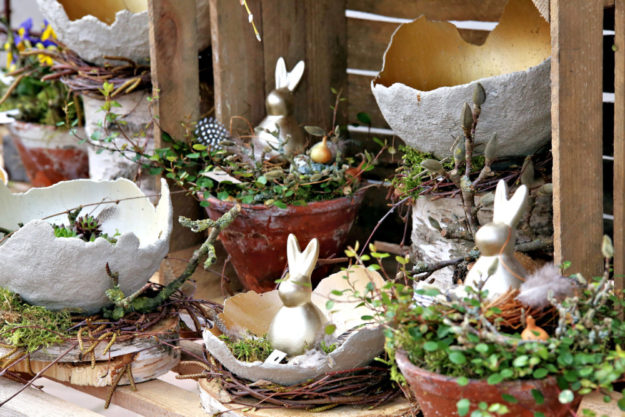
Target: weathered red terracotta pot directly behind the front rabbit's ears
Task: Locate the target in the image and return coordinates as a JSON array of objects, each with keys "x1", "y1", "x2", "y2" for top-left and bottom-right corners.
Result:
[{"x1": 206, "y1": 192, "x2": 364, "y2": 292}]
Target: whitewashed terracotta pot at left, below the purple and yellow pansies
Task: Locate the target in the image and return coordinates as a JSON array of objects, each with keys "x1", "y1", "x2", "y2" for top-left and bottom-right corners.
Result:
[{"x1": 9, "y1": 121, "x2": 89, "y2": 187}]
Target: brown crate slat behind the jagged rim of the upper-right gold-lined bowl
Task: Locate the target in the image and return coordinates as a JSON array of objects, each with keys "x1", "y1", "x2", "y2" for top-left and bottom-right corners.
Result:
[{"x1": 347, "y1": 19, "x2": 490, "y2": 71}]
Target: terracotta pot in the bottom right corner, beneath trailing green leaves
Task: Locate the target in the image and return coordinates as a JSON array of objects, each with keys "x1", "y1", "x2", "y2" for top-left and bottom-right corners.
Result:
[{"x1": 395, "y1": 351, "x2": 581, "y2": 417}]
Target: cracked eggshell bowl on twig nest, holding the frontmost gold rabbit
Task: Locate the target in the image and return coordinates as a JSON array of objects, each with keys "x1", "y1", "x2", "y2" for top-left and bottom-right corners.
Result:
[{"x1": 204, "y1": 267, "x2": 384, "y2": 385}]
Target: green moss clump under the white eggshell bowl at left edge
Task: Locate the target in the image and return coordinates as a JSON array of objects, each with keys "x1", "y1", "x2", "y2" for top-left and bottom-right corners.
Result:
[{"x1": 0, "y1": 287, "x2": 72, "y2": 352}]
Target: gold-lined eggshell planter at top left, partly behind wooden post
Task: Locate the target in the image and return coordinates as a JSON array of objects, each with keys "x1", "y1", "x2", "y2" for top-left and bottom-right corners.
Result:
[{"x1": 37, "y1": 0, "x2": 210, "y2": 64}]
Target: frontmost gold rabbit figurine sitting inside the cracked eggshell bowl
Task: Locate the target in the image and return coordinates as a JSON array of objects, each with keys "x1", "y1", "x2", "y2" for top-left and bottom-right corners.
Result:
[{"x1": 267, "y1": 234, "x2": 327, "y2": 356}]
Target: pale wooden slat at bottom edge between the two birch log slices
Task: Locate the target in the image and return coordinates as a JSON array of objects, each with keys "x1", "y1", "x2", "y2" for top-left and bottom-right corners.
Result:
[{"x1": 69, "y1": 379, "x2": 207, "y2": 417}]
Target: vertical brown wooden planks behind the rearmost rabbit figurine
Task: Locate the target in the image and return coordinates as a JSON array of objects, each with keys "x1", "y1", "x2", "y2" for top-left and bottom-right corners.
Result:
[{"x1": 210, "y1": 0, "x2": 347, "y2": 133}]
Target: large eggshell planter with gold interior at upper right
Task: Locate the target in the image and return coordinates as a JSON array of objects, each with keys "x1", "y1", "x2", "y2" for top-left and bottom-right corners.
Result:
[{"x1": 371, "y1": 0, "x2": 551, "y2": 158}]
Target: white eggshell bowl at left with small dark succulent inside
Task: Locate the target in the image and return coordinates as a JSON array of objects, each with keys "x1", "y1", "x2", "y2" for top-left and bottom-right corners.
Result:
[{"x1": 0, "y1": 179, "x2": 172, "y2": 313}]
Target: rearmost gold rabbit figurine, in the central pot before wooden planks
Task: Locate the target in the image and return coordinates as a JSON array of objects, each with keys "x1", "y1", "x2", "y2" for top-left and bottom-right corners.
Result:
[{"x1": 254, "y1": 57, "x2": 306, "y2": 158}]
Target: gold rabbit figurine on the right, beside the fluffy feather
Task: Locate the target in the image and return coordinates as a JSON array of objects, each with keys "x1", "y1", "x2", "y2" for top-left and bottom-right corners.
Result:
[{"x1": 464, "y1": 180, "x2": 528, "y2": 299}]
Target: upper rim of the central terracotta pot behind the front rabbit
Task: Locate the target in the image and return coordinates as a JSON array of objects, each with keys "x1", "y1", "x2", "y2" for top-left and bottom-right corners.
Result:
[{"x1": 199, "y1": 188, "x2": 367, "y2": 216}]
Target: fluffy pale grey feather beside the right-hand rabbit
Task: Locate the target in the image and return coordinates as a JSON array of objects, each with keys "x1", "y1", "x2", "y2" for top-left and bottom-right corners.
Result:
[{"x1": 517, "y1": 263, "x2": 575, "y2": 308}]
